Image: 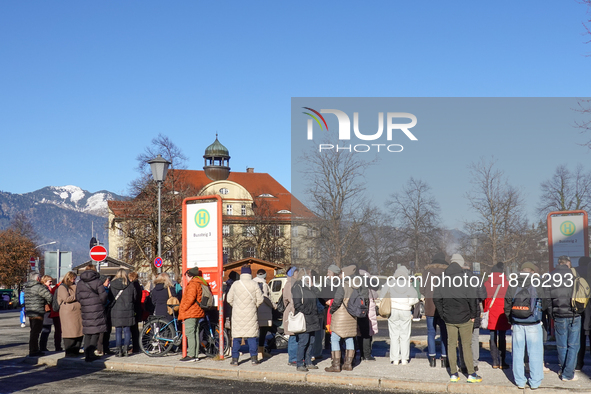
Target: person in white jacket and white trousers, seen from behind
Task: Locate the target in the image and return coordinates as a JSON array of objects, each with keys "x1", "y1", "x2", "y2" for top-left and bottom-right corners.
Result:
[{"x1": 380, "y1": 266, "x2": 419, "y2": 365}]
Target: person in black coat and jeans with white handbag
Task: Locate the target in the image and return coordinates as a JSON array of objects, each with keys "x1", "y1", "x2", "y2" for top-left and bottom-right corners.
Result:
[{"x1": 291, "y1": 269, "x2": 321, "y2": 372}]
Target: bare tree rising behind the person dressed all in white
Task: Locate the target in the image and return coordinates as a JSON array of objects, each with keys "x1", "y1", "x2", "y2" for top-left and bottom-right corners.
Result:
[{"x1": 387, "y1": 177, "x2": 441, "y2": 271}]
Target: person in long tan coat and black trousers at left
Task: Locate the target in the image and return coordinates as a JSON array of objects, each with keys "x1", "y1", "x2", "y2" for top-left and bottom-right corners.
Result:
[{"x1": 56, "y1": 271, "x2": 84, "y2": 357}]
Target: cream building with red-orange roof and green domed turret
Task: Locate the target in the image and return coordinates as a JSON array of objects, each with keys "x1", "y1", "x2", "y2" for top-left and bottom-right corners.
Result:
[{"x1": 108, "y1": 135, "x2": 318, "y2": 276}]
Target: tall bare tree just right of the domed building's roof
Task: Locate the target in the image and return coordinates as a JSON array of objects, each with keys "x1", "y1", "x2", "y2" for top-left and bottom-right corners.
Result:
[{"x1": 303, "y1": 146, "x2": 373, "y2": 267}]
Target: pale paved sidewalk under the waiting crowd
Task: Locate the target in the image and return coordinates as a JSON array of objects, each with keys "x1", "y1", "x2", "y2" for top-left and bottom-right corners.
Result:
[{"x1": 0, "y1": 313, "x2": 591, "y2": 394}]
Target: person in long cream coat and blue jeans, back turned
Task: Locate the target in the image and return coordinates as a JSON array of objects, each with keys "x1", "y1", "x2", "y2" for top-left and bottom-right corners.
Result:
[{"x1": 227, "y1": 265, "x2": 263, "y2": 366}]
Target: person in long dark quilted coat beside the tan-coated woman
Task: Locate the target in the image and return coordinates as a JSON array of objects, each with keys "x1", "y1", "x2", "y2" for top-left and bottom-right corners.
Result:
[{"x1": 76, "y1": 265, "x2": 107, "y2": 361}]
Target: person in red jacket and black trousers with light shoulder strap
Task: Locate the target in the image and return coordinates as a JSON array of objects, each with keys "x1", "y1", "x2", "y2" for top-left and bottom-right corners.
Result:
[{"x1": 484, "y1": 262, "x2": 511, "y2": 369}]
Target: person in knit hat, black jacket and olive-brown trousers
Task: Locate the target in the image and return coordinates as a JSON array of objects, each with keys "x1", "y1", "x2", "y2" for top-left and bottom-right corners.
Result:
[{"x1": 433, "y1": 254, "x2": 482, "y2": 383}]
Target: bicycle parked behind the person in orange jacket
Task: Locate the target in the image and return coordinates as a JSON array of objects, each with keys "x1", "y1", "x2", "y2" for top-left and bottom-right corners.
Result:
[{"x1": 140, "y1": 315, "x2": 230, "y2": 358}]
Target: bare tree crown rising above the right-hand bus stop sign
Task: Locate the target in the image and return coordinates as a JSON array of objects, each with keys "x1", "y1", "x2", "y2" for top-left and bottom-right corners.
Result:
[{"x1": 538, "y1": 164, "x2": 591, "y2": 217}]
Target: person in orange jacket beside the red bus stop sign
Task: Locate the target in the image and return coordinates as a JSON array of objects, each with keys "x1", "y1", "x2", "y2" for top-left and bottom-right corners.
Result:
[{"x1": 179, "y1": 267, "x2": 205, "y2": 362}]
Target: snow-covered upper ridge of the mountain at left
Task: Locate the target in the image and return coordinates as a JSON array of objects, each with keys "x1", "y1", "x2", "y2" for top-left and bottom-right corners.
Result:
[{"x1": 22, "y1": 185, "x2": 123, "y2": 217}]
